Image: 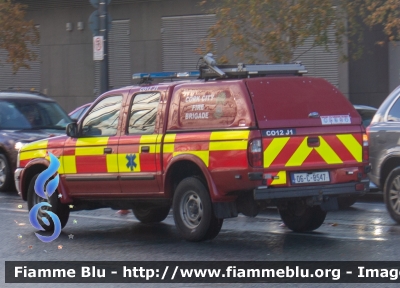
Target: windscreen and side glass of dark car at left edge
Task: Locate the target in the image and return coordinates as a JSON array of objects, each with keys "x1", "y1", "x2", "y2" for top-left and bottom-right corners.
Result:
[{"x1": 0, "y1": 99, "x2": 72, "y2": 130}]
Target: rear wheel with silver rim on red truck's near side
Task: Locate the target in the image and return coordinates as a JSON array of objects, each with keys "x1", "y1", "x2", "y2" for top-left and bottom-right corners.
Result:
[{"x1": 173, "y1": 177, "x2": 223, "y2": 242}]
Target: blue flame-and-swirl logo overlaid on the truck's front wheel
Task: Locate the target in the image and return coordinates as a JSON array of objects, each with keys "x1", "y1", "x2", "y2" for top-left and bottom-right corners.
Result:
[{"x1": 29, "y1": 153, "x2": 61, "y2": 243}]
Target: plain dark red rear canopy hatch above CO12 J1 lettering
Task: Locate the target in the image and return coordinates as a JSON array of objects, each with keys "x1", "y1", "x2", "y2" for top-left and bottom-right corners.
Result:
[{"x1": 246, "y1": 77, "x2": 361, "y2": 128}]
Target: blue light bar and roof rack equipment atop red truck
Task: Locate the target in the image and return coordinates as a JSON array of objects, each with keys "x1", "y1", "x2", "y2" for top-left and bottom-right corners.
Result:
[{"x1": 132, "y1": 53, "x2": 307, "y2": 84}]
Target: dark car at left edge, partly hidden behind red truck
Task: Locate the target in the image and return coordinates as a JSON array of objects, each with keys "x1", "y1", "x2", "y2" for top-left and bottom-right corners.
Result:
[{"x1": 0, "y1": 91, "x2": 72, "y2": 192}]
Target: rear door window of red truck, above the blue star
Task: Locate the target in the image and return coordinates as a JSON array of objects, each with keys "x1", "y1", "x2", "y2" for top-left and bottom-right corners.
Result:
[{"x1": 128, "y1": 92, "x2": 160, "y2": 134}]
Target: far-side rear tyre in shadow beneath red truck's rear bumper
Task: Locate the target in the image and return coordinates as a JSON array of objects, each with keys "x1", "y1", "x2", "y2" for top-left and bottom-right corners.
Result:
[{"x1": 279, "y1": 202, "x2": 326, "y2": 232}]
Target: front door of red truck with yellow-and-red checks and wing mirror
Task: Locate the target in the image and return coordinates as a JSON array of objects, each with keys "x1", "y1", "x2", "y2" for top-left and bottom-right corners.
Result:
[{"x1": 63, "y1": 95, "x2": 124, "y2": 196}]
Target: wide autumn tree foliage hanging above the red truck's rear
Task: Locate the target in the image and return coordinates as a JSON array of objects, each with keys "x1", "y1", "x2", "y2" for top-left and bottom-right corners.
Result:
[{"x1": 197, "y1": 0, "x2": 400, "y2": 63}]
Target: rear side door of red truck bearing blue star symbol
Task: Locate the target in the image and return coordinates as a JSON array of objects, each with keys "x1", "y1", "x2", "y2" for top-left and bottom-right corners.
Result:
[{"x1": 118, "y1": 91, "x2": 162, "y2": 196}]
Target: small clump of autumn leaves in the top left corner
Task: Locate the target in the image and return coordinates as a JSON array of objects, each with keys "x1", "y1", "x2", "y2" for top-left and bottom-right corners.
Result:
[{"x1": 0, "y1": 0, "x2": 39, "y2": 72}]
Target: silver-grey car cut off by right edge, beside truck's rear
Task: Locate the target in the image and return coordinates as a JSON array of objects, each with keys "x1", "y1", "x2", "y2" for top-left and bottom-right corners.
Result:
[{"x1": 367, "y1": 86, "x2": 400, "y2": 223}]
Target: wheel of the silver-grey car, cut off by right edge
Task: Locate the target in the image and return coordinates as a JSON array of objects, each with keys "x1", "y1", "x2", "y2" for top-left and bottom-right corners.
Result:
[{"x1": 383, "y1": 167, "x2": 400, "y2": 224}]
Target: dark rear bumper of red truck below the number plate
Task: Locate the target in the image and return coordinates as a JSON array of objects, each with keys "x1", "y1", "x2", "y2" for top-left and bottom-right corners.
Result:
[{"x1": 254, "y1": 179, "x2": 369, "y2": 200}]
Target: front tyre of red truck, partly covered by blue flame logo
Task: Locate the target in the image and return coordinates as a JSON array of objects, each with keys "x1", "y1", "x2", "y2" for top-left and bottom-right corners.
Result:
[{"x1": 28, "y1": 174, "x2": 70, "y2": 231}]
